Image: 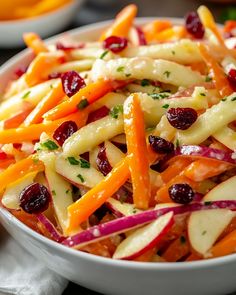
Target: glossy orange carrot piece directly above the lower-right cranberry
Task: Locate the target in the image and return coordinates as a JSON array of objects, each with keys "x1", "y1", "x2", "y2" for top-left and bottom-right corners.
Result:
[{"x1": 184, "y1": 159, "x2": 232, "y2": 181}]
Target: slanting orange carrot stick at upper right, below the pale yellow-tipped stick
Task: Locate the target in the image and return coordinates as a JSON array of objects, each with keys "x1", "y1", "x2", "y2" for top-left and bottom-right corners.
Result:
[{"x1": 198, "y1": 44, "x2": 233, "y2": 97}]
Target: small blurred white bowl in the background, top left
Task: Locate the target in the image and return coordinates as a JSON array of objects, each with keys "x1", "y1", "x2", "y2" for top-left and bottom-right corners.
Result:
[{"x1": 0, "y1": 0, "x2": 84, "y2": 48}]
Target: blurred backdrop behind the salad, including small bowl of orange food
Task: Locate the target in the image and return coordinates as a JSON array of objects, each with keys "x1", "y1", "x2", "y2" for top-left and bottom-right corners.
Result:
[{"x1": 0, "y1": 0, "x2": 236, "y2": 295}]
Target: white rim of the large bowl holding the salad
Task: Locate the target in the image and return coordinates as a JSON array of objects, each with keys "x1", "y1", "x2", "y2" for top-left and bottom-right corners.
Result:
[{"x1": 0, "y1": 17, "x2": 232, "y2": 271}]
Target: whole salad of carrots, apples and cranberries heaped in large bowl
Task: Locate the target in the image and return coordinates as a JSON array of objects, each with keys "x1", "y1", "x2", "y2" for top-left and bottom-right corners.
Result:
[{"x1": 0, "y1": 4, "x2": 236, "y2": 262}]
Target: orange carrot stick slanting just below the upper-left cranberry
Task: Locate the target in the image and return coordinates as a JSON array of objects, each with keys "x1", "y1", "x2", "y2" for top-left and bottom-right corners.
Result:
[{"x1": 43, "y1": 80, "x2": 123, "y2": 120}]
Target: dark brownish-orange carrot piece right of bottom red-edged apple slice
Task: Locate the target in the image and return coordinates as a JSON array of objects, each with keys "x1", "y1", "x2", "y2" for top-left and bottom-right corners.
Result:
[{"x1": 162, "y1": 234, "x2": 190, "y2": 262}]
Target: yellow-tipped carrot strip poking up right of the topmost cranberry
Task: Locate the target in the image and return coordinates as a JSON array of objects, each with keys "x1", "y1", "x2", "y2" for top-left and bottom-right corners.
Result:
[{"x1": 197, "y1": 5, "x2": 225, "y2": 47}]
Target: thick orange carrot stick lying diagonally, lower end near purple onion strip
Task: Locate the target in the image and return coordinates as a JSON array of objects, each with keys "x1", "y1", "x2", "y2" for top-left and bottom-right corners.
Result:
[{"x1": 68, "y1": 158, "x2": 129, "y2": 232}]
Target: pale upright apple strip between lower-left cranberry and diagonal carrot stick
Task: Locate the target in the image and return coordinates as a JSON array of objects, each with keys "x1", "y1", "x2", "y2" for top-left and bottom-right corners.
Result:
[{"x1": 39, "y1": 152, "x2": 73, "y2": 234}]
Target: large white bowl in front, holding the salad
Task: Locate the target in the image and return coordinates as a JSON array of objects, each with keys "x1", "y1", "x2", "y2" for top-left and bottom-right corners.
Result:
[{"x1": 0, "y1": 18, "x2": 236, "y2": 295}]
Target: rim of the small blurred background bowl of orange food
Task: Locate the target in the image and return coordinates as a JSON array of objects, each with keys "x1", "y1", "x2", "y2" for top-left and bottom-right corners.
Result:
[{"x1": 0, "y1": 0, "x2": 77, "y2": 26}]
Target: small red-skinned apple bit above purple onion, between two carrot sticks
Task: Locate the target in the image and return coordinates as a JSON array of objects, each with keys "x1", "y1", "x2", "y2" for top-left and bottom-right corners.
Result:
[{"x1": 106, "y1": 198, "x2": 142, "y2": 217}]
